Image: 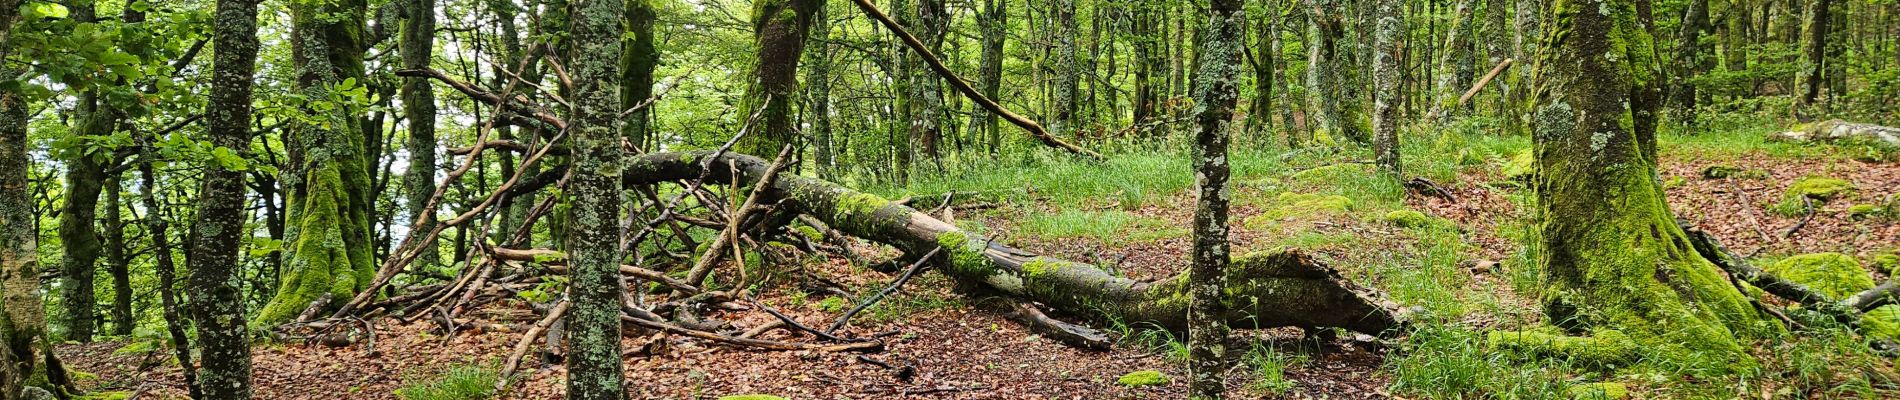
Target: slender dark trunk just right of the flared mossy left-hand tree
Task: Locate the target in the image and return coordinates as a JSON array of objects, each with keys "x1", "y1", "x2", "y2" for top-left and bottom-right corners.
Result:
[{"x1": 397, "y1": 0, "x2": 443, "y2": 265}]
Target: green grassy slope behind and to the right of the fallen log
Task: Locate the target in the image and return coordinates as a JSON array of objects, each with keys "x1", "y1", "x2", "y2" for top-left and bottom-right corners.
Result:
[{"x1": 868, "y1": 123, "x2": 1894, "y2": 398}]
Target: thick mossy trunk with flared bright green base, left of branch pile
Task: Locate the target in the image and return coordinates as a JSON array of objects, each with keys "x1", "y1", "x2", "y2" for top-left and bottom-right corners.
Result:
[{"x1": 262, "y1": 0, "x2": 376, "y2": 326}]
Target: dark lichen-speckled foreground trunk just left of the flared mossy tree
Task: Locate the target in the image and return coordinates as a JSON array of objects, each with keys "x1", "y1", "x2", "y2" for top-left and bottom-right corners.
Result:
[{"x1": 189, "y1": 0, "x2": 258, "y2": 400}]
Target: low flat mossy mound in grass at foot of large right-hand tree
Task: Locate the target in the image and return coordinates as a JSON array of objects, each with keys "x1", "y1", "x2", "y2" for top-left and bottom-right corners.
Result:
[{"x1": 1484, "y1": 328, "x2": 1638, "y2": 368}]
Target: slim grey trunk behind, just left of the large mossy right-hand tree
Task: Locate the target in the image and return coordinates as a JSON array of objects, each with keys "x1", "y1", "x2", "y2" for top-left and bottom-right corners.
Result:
[{"x1": 1372, "y1": 0, "x2": 1406, "y2": 176}]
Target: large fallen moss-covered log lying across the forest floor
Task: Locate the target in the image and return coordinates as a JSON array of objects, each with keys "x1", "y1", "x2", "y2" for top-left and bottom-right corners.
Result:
[{"x1": 625, "y1": 152, "x2": 1404, "y2": 334}]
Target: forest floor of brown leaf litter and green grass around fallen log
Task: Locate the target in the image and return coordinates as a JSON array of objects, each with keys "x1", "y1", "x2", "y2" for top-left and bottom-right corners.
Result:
[{"x1": 61, "y1": 127, "x2": 1900, "y2": 398}]
